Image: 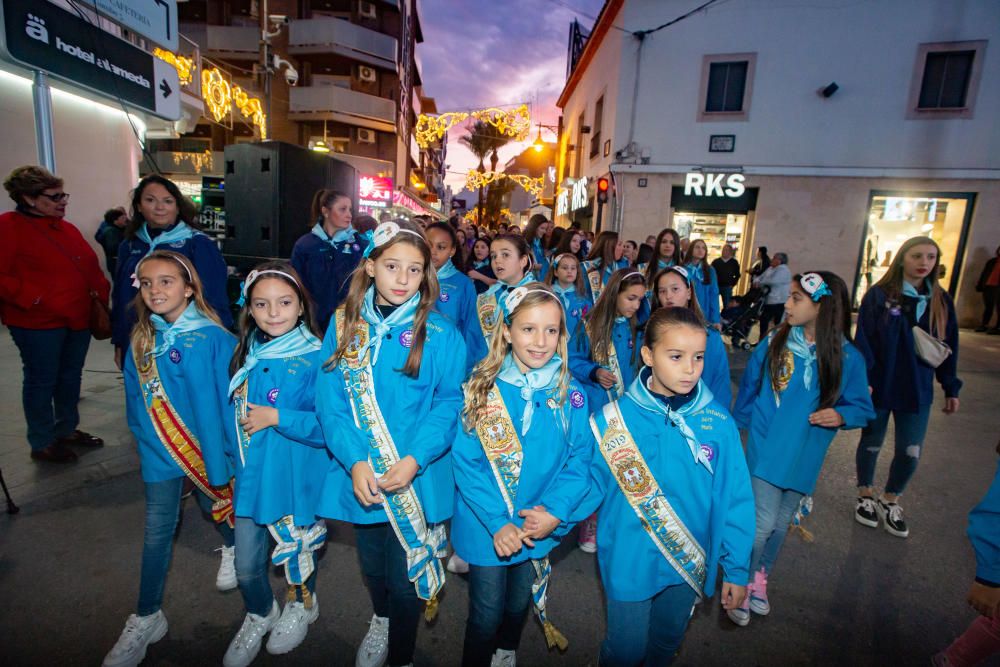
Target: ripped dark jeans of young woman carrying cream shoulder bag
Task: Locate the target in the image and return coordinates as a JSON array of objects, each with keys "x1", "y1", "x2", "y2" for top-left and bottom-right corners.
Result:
[{"x1": 855, "y1": 405, "x2": 931, "y2": 495}]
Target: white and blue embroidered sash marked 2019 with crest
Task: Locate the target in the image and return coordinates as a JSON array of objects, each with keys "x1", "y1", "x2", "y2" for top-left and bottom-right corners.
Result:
[{"x1": 590, "y1": 401, "x2": 707, "y2": 598}]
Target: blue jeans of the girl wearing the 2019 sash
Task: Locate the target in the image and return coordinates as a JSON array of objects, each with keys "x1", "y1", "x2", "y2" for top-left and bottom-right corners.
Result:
[{"x1": 598, "y1": 584, "x2": 695, "y2": 667}]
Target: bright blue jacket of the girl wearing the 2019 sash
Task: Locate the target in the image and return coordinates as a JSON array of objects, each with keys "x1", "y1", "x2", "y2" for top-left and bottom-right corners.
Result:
[{"x1": 574, "y1": 368, "x2": 755, "y2": 602}]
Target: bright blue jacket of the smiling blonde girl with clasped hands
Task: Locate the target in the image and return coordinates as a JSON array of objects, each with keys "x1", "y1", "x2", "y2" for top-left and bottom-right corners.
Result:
[{"x1": 451, "y1": 380, "x2": 593, "y2": 566}]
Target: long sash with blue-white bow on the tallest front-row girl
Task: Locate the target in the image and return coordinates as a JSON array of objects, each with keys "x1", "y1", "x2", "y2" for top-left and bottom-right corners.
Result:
[{"x1": 335, "y1": 309, "x2": 448, "y2": 621}]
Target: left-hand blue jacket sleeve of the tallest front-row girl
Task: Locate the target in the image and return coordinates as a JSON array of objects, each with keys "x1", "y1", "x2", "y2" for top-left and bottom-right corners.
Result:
[{"x1": 316, "y1": 319, "x2": 368, "y2": 472}]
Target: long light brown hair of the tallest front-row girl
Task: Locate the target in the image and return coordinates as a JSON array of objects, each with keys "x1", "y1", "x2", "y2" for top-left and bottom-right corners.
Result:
[{"x1": 323, "y1": 221, "x2": 441, "y2": 378}]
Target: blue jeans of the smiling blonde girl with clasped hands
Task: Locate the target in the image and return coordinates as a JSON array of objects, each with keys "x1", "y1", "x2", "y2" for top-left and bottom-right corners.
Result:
[{"x1": 462, "y1": 560, "x2": 535, "y2": 667}]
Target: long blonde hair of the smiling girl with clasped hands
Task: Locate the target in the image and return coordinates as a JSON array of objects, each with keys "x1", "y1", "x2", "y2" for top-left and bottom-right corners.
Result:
[{"x1": 462, "y1": 282, "x2": 570, "y2": 432}]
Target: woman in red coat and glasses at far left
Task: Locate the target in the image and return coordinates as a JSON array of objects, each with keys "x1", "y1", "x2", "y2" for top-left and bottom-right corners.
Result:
[{"x1": 0, "y1": 166, "x2": 111, "y2": 463}]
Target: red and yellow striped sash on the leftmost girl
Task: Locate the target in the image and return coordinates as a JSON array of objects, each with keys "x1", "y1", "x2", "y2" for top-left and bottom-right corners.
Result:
[{"x1": 132, "y1": 346, "x2": 235, "y2": 527}]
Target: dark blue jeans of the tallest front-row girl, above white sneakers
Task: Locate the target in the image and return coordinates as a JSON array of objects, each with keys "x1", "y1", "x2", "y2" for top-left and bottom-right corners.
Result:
[{"x1": 354, "y1": 523, "x2": 420, "y2": 667}]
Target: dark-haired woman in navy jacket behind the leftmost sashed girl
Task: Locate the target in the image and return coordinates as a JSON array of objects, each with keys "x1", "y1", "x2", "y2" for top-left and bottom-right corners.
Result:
[{"x1": 111, "y1": 174, "x2": 233, "y2": 368}]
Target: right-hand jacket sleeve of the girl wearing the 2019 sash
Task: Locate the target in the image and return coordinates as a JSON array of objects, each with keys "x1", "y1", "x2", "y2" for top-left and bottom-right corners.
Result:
[{"x1": 715, "y1": 420, "x2": 756, "y2": 586}]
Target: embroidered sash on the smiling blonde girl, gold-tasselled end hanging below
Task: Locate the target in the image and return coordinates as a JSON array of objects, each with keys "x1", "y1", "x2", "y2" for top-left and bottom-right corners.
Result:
[{"x1": 476, "y1": 385, "x2": 569, "y2": 651}]
